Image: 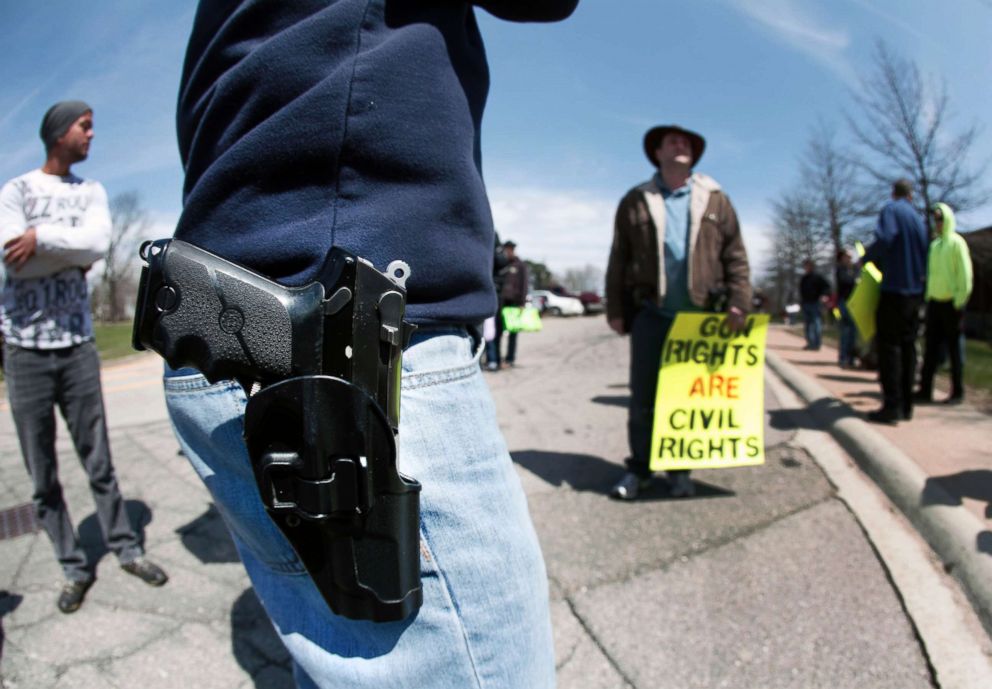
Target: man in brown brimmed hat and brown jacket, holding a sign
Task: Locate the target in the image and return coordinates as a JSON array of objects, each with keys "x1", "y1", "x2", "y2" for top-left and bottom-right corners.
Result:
[{"x1": 606, "y1": 125, "x2": 751, "y2": 500}]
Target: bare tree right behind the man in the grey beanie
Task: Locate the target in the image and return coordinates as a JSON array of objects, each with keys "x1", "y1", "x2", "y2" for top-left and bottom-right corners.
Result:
[{"x1": 94, "y1": 191, "x2": 151, "y2": 322}]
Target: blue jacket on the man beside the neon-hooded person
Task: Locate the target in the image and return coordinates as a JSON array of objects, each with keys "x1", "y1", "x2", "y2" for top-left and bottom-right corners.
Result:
[{"x1": 865, "y1": 199, "x2": 929, "y2": 296}]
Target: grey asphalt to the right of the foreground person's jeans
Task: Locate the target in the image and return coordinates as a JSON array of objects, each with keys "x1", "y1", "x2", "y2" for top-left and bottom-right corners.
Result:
[{"x1": 488, "y1": 318, "x2": 968, "y2": 689}]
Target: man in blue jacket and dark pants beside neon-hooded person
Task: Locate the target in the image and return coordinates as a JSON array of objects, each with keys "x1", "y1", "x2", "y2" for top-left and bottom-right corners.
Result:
[{"x1": 864, "y1": 179, "x2": 928, "y2": 425}]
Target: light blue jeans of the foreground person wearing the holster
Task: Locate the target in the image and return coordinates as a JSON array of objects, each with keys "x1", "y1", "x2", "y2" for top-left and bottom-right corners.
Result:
[{"x1": 165, "y1": 329, "x2": 555, "y2": 689}]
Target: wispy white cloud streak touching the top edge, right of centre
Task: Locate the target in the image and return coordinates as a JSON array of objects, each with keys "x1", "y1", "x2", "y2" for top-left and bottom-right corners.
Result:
[{"x1": 729, "y1": 0, "x2": 858, "y2": 87}]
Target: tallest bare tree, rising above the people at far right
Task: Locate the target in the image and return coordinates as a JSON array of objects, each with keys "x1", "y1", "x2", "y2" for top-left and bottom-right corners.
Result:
[{"x1": 848, "y1": 42, "x2": 990, "y2": 211}]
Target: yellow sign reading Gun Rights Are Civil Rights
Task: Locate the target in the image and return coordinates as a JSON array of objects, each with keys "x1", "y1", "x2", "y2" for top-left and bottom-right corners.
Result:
[{"x1": 651, "y1": 313, "x2": 768, "y2": 471}]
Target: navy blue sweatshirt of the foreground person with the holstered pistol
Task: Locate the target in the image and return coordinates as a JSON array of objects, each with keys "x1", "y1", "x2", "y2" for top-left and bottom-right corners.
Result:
[{"x1": 176, "y1": 0, "x2": 578, "y2": 323}]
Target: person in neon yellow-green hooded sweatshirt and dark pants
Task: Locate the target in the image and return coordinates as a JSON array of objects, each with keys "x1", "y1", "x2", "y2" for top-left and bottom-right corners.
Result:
[{"x1": 915, "y1": 203, "x2": 972, "y2": 404}]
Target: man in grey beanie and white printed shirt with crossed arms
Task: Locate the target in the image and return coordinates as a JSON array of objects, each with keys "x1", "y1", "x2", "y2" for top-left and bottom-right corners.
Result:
[{"x1": 0, "y1": 101, "x2": 168, "y2": 613}]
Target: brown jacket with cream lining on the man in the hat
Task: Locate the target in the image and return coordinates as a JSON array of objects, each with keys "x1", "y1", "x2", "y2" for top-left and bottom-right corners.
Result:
[{"x1": 606, "y1": 172, "x2": 751, "y2": 328}]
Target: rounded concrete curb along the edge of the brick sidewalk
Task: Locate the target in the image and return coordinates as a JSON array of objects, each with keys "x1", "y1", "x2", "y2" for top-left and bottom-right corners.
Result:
[{"x1": 765, "y1": 351, "x2": 992, "y2": 635}]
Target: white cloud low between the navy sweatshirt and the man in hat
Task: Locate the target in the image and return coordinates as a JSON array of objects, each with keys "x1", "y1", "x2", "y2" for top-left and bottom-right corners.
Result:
[{"x1": 489, "y1": 187, "x2": 620, "y2": 274}]
